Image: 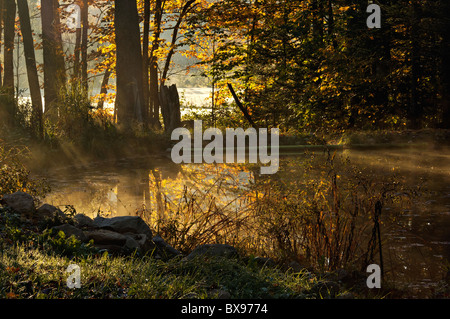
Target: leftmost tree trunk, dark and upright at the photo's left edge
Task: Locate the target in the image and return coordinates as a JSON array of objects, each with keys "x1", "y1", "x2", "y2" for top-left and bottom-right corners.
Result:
[{"x1": 3, "y1": 0, "x2": 16, "y2": 101}]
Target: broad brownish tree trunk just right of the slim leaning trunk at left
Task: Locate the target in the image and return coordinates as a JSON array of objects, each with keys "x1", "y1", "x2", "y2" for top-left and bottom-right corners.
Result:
[{"x1": 41, "y1": 0, "x2": 66, "y2": 117}]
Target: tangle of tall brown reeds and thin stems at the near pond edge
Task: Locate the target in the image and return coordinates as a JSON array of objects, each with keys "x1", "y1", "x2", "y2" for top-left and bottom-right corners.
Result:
[{"x1": 147, "y1": 153, "x2": 408, "y2": 271}]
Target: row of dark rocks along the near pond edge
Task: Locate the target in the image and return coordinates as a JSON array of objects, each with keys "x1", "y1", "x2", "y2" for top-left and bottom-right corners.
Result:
[{"x1": 0, "y1": 192, "x2": 243, "y2": 260}]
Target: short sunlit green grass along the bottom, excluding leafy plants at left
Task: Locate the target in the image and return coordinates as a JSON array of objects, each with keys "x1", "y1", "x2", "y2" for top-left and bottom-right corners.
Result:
[{"x1": 0, "y1": 245, "x2": 354, "y2": 299}]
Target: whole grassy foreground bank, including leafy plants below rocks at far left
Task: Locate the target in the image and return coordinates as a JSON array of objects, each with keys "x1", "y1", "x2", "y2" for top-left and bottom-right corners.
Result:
[{"x1": 0, "y1": 214, "x2": 389, "y2": 299}]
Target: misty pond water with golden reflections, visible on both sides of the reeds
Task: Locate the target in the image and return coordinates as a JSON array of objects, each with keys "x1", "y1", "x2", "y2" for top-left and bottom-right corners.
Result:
[{"x1": 37, "y1": 147, "x2": 450, "y2": 297}]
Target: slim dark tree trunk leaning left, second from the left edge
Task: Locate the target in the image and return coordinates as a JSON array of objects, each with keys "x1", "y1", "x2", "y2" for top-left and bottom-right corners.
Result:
[{"x1": 17, "y1": 0, "x2": 43, "y2": 138}]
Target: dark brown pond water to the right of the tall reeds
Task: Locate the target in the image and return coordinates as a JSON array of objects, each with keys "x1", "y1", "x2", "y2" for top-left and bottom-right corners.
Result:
[{"x1": 342, "y1": 149, "x2": 450, "y2": 294}]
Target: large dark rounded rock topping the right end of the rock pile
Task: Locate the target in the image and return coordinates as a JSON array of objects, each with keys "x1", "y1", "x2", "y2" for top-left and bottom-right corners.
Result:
[{"x1": 94, "y1": 216, "x2": 153, "y2": 238}]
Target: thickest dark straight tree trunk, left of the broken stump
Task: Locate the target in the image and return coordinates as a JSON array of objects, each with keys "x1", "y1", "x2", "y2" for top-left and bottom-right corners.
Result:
[{"x1": 114, "y1": 0, "x2": 144, "y2": 130}]
